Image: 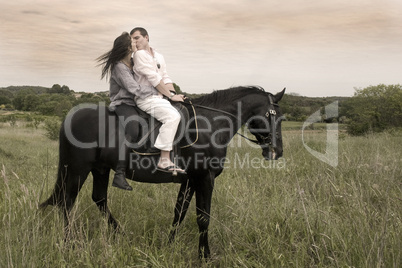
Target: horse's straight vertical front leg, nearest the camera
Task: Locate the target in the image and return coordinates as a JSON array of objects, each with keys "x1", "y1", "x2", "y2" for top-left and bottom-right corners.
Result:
[{"x1": 195, "y1": 174, "x2": 215, "y2": 259}]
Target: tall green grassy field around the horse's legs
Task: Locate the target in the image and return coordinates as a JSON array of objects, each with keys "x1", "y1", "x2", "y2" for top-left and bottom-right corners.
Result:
[{"x1": 0, "y1": 122, "x2": 402, "y2": 267}]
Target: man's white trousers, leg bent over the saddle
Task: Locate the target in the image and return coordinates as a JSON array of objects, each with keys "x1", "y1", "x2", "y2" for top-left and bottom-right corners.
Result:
[{"x1": 136, "y1": 96, "x2": 181, "y2": 151}]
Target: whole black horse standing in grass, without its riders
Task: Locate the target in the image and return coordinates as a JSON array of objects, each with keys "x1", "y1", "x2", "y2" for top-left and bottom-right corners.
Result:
[{"x1": 41, "y1": 87, "x2": 285, "y2": 258}]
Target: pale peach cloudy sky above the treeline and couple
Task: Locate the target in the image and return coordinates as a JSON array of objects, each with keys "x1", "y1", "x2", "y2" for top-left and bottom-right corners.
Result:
[{"x1": 0, "y1": 0, "x2": 402, "y2": 97}]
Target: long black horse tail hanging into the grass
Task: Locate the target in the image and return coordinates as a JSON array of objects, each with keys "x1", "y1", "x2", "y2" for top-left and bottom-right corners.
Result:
[{"x1": 39, "y1": 123, "x2": 68, "y2": 209}]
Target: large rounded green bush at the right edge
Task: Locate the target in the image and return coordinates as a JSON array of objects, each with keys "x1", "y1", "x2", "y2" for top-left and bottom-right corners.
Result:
[{"x1": 343, "y1": 84, "x2": 402, "y2": 135}]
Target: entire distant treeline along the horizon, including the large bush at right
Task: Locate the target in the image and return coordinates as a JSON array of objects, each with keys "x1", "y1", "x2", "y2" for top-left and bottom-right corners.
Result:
[{"x1": 0, "y1": 84, "x2": 402, "y2": 135}]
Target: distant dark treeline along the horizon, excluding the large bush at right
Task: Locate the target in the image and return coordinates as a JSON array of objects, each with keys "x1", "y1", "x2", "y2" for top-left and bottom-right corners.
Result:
[{"x1": 0, "y1": 84, "x2": 348, "y2": 121}]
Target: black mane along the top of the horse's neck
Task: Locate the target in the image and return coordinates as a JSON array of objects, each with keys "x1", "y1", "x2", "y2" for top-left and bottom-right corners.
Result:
[{"x1": 193, "y1": 86, "x2": 265, "y2": 108}]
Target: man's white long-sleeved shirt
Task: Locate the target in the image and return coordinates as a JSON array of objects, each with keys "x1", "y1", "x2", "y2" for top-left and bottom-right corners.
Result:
[{"x1": 133, "y1": 48, "x2": 173, "y2": 87}]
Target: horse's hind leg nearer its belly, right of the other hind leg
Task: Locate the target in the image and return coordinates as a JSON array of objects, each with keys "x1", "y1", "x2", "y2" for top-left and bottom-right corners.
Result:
[{"x1": 91, "y1": 169, "x2": 119, "y2": 230}]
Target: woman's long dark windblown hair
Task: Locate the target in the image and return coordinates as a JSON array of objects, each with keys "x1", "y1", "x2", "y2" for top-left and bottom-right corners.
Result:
[{"x1": 96, "y1": 32, "x2": 131, "y2": 79}]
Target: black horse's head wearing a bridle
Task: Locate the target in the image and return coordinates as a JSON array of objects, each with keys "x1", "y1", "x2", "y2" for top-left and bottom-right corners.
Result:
[{"x1": 247, "y1": 88, "x2": 285, "y2": 160}]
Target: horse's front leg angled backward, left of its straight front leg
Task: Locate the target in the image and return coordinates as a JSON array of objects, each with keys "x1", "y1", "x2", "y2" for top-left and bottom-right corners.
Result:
[{"x1": 169, "y1": 180, "x2": 194, "y2": 243}]
